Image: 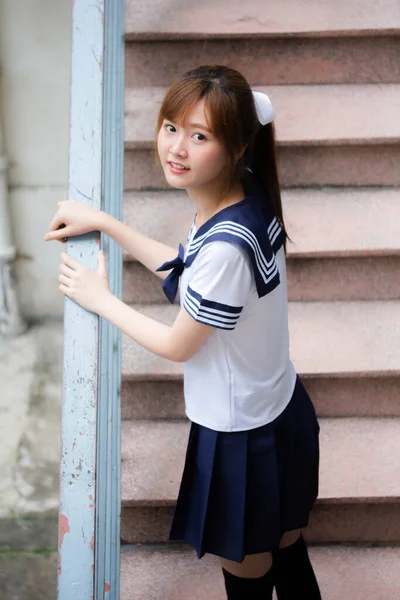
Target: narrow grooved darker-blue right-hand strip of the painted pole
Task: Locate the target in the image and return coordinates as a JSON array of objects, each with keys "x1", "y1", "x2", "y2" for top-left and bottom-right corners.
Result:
[{"x1": 95, "y1": 0, "x2": 125, "y2": 600}]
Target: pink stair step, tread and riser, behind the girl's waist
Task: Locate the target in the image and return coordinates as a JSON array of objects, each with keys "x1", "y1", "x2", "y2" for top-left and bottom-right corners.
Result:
[{"x1": 122, "y1": 301, "x2": 400, "y2": 419}]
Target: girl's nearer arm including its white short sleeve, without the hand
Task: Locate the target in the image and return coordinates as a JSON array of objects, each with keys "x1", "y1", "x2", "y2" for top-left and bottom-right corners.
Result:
[{"x1": 96, "y1": 242, "x2": 252, "y2": 362}]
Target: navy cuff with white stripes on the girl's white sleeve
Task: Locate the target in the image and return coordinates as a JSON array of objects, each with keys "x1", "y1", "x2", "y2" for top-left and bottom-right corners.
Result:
[{"x1": 183, "y1": 286, "x2": 243, "y2": 329}]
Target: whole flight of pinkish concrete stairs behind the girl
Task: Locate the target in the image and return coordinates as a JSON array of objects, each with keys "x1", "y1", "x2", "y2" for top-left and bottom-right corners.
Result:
[{"x1": 121, "y1": 0, "x2": 400, "y2": 600}]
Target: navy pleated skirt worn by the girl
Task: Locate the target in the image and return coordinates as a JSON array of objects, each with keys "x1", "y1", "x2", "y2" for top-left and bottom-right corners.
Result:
[{"x1": 169, "y1": 378, "x2": 319, "y2": 562}]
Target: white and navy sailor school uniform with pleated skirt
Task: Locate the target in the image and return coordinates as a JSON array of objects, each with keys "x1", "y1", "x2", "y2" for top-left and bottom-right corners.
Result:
[{"x1": 158, "y1": 182, "x2": 319, "y2": 562}]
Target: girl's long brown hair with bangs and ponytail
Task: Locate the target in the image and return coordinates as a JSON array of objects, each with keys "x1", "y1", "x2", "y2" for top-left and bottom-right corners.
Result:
[{"x1": 156, "y1": 65, "x2": 287, "y2": 241}]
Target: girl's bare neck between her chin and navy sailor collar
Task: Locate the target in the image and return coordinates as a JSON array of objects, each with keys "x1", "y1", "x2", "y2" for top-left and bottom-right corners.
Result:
[{"x1": 186, "y1": 181, "x2": 245, "y2": 229}]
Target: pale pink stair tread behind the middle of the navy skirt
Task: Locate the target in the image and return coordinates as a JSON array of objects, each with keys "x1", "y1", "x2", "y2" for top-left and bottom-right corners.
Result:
[{"x1": 122, "y1": 418, "x2": 400, "y2": 507}]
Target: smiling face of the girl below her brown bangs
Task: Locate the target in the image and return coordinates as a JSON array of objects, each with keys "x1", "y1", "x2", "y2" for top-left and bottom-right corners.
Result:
[{"x1": 157, "y1": 100, "x2": 229, "y2": 190}]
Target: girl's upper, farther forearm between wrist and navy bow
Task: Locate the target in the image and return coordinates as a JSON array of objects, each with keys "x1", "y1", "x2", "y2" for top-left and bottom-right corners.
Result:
[{"x1": 100, "y1": 212, "x2": 178, "y2": 279}]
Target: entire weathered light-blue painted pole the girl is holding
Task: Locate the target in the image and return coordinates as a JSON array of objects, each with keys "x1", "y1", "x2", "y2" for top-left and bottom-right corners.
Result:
[{"x1": 58, "y1": 0, "x2": 124, "y2": 600}]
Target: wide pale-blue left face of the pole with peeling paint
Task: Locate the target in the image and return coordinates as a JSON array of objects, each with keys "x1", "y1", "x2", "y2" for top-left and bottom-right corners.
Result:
[{"x1": 58, "y1": 0, "x2": 104, "y2": 600}]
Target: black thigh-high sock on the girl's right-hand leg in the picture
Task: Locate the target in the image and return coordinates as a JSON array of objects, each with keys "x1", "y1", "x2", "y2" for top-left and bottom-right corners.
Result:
[{"x1": 273, "y1": 535, "x2": 321, "y2": 600}]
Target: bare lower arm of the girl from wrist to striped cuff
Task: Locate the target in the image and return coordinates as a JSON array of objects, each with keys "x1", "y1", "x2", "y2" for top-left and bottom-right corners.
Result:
[{"x1": 97, "y1": 294, "x2": 213, "y2": 362}]
